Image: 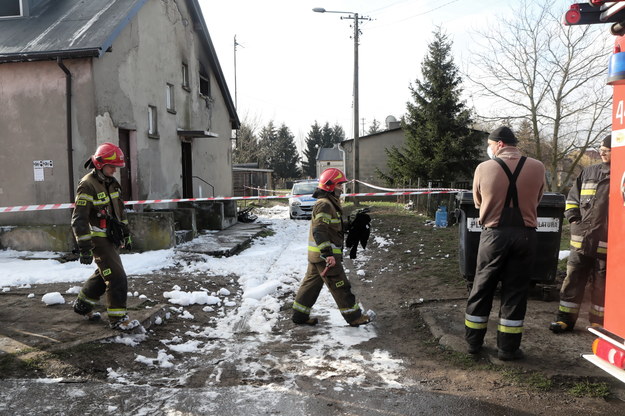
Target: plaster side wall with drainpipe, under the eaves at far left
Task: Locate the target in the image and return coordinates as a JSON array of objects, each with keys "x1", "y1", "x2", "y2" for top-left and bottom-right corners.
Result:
[{"x1": 0, "y1": 60, "x2": 95, "y2": 225}]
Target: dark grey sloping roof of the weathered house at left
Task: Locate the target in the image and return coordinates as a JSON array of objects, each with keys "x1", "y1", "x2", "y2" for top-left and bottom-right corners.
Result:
[{"x1": 0, "y1": 0, "x2": 240, "y2": 129}]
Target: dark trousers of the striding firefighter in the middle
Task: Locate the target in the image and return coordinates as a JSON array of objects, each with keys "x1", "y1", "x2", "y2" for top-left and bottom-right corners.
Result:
[{"x1": 293, "y1": 261, "x2": 362, "y2": 323}]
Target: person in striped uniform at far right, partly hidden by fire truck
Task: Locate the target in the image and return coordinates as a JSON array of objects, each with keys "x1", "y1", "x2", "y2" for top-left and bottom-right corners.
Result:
[{"x1": 549, "y1": 136, "x2": 612, "y2": 334}]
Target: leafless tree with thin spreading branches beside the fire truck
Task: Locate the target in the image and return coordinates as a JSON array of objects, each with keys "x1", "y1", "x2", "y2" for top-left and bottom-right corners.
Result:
[{"x1": 466, "y1": 0, "x2": 611, "y2": 191}]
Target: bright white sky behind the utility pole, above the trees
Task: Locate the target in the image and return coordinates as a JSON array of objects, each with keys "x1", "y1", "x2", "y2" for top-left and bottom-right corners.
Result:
[{"x1": 200, "y1": 0, "x2": 528, "y2": 148}]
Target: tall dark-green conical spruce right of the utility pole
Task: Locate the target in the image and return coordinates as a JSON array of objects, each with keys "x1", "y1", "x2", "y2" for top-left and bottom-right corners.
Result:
[{"x1": 379, "y1": 28, "x2": 484, "y2": 185}]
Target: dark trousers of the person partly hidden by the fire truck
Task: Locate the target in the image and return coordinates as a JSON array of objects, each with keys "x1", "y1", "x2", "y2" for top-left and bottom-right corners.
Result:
[{"x1": 557, "y1": 250, "x2": 606, "y2": 329}]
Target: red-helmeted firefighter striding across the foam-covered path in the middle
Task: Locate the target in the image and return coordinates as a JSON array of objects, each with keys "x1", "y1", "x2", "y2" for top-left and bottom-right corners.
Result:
[{"x1": 292, "y1": 168, "x2": 370, "y2": 326}]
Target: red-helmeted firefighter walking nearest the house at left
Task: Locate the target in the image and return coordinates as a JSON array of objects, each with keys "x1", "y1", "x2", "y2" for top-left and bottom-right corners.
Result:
[{"x1": 72, "y1": 143, "x2": 139, "y2": 330}]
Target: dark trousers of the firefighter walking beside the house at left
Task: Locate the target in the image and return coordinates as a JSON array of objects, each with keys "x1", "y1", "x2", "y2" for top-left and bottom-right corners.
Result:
[{"x1": 78, "y1": 237, "x2": 128, "y2": 322}]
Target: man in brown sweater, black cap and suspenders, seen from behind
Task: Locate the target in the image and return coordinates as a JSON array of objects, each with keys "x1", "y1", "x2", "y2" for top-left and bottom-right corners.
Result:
[{"x1": 465, "y1": 127, "x2": 545, "y2": 361}]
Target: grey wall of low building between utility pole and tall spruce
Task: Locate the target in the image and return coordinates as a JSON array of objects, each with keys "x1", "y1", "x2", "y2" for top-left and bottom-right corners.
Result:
[{"x1": 342, "y1": 129, "x2": 405, "y2": 192}]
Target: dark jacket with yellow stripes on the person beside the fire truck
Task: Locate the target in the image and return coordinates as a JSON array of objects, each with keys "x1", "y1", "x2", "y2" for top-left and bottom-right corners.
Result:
[{"x1": 564, "y1": 163, "x2": 610, "y2": 259}]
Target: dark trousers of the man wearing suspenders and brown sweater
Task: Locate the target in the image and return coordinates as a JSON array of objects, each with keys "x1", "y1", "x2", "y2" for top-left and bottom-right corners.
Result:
[{"x1": 465, "y1": 227, "x2": 536, "y2": 352}]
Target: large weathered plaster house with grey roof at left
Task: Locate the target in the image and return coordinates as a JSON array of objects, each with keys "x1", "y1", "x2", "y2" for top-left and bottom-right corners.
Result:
[{"x1": 0, "y1": 0, "x2": 240, "y2": 225}]
